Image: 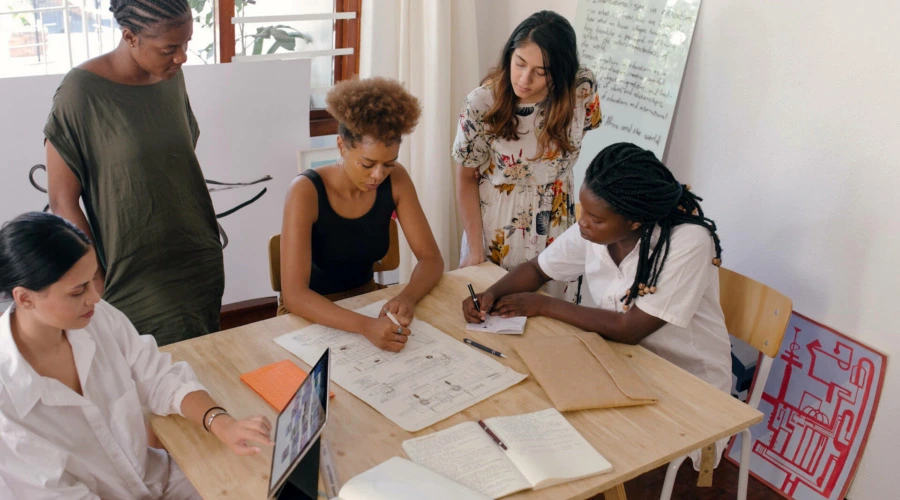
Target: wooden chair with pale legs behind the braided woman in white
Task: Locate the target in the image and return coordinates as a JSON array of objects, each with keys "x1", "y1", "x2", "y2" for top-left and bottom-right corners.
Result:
[{"x1": 660, "y1": 268, "x2": 793, "y2": 500}]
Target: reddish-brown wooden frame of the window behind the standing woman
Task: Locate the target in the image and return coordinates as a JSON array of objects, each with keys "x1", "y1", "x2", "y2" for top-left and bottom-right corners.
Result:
[{"x1": 216, "y1": 0, "x2": 362, "y2": 137}]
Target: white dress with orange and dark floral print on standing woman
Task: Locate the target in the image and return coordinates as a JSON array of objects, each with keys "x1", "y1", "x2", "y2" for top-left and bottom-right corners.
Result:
[{"x1": 453, "y1": 64, "x2": 601, "y2": 297}]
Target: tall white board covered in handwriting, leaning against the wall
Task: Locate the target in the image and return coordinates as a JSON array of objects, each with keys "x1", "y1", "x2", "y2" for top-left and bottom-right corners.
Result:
[{"x1": 574, "y1": 0, "x2": 700, "y2": 186}]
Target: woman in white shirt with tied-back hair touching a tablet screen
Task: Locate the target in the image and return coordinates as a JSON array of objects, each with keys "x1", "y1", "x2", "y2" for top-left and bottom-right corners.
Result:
[{"x1": 0, "y1": 213, "x2": 272, "y2": 500}]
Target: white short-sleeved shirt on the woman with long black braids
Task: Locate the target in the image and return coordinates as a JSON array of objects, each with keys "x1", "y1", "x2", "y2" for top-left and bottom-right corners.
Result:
[{"x1": 538, "y1": 224, "x2": 731, "y2": 393}]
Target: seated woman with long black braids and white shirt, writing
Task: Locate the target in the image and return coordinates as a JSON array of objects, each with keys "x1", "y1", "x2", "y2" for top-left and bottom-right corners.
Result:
[{"x1": 463, "y1": 143, "x2": 731, "y2": 467}]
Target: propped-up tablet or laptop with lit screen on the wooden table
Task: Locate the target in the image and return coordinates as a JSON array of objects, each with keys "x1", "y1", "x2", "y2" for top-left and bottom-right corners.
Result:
[{"x1": 269, "y1": 348, "x2": 331, "y2": 499}]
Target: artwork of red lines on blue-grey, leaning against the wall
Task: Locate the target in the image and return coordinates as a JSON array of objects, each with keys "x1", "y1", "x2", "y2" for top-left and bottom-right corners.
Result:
[{"x1": 727, "y1": 313, "x2": 885, "y2": 500}]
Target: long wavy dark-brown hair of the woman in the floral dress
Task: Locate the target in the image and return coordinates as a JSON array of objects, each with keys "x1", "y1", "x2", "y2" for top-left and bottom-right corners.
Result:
[{"x1": 482, "y1": 10, "x2": 579, "y2": 158}]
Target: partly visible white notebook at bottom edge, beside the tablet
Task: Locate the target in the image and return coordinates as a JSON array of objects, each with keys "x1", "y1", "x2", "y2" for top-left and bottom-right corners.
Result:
[{"x1": 334, "y1": 457, "x2": 489, "y2": 500}]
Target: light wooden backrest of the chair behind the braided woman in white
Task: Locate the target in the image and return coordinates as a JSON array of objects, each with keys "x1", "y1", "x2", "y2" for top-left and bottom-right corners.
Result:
[{"x1": 719, "y1": 267, "x2": 793, "y2": 358}]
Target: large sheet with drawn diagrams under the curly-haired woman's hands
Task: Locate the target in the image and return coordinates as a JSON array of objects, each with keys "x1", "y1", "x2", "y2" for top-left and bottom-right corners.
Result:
[{"x1": 275, "y1": 301, "x2": 525, "y2": 432}]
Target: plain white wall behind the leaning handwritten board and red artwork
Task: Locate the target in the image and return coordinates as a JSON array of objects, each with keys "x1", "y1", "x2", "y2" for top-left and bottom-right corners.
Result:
[{"x1": 479, "y1": 0, "x2": 900, "y2": 500}]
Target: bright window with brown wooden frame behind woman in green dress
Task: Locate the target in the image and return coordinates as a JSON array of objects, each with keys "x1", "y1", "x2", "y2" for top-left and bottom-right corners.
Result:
[{"x1": 0, "y1": 0, "x2": 362, "y2": 136}]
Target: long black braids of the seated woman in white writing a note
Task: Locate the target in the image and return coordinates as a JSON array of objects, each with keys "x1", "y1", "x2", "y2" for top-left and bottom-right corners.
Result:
[{"x1": 584, "y1": 142, "x2": 722, "y2": 311}]
